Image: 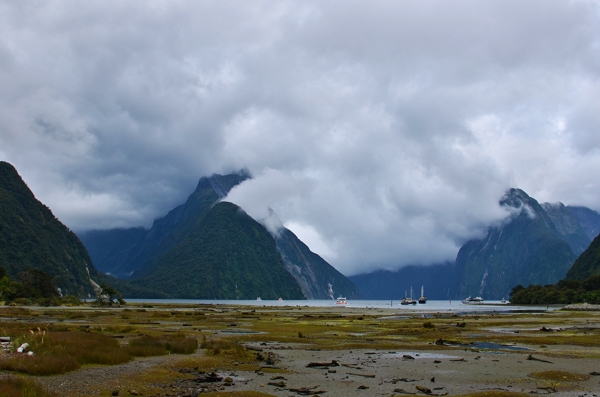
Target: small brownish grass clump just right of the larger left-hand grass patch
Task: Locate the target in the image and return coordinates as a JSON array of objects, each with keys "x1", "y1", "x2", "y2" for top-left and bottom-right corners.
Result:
[{"x1": 127, "y1": 334, "x2": 198, "y2": 357}]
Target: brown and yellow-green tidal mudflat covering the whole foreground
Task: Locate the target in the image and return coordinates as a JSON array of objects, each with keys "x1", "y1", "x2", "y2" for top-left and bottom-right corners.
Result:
[{"x1": 0, "y1": 304, "x2": 600, "y2": 397}]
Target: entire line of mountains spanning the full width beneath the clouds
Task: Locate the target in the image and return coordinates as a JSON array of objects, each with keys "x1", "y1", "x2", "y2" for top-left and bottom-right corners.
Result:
[{"x1": 0, "y1": 158, "x2": 600, "y2": 300}]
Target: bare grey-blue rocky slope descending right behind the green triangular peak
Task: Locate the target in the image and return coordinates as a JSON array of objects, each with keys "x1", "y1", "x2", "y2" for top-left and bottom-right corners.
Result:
[{"x1": 275, "y1": 228, "x2": 360, "y2": 299}]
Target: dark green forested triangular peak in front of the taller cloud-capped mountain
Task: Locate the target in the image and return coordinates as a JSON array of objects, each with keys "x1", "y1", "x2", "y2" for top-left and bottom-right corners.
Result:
[{"x1": 131, "y1": 202, "x2": 303, "y2": 299}]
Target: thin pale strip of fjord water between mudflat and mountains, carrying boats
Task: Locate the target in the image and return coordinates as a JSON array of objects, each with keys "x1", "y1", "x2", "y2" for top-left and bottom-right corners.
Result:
[{"x1": 122, "y1": 299, "x2": 562, "y2": 313}]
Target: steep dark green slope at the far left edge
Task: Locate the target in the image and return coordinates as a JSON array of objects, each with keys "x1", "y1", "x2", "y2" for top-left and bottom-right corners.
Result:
[{"x1": 0, "y1": 162, "x2": 98, "y2": 297}]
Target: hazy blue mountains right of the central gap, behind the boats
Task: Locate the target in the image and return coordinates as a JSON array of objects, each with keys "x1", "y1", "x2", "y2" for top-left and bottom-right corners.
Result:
[{"x1": 350, "y1": 189, "x2": 600, "y2": 299}]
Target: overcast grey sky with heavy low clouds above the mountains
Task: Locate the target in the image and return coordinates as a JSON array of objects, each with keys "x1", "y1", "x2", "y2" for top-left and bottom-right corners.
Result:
[{"x1": 0, "y1": 0, "x2": 600, "y2": 275}]
